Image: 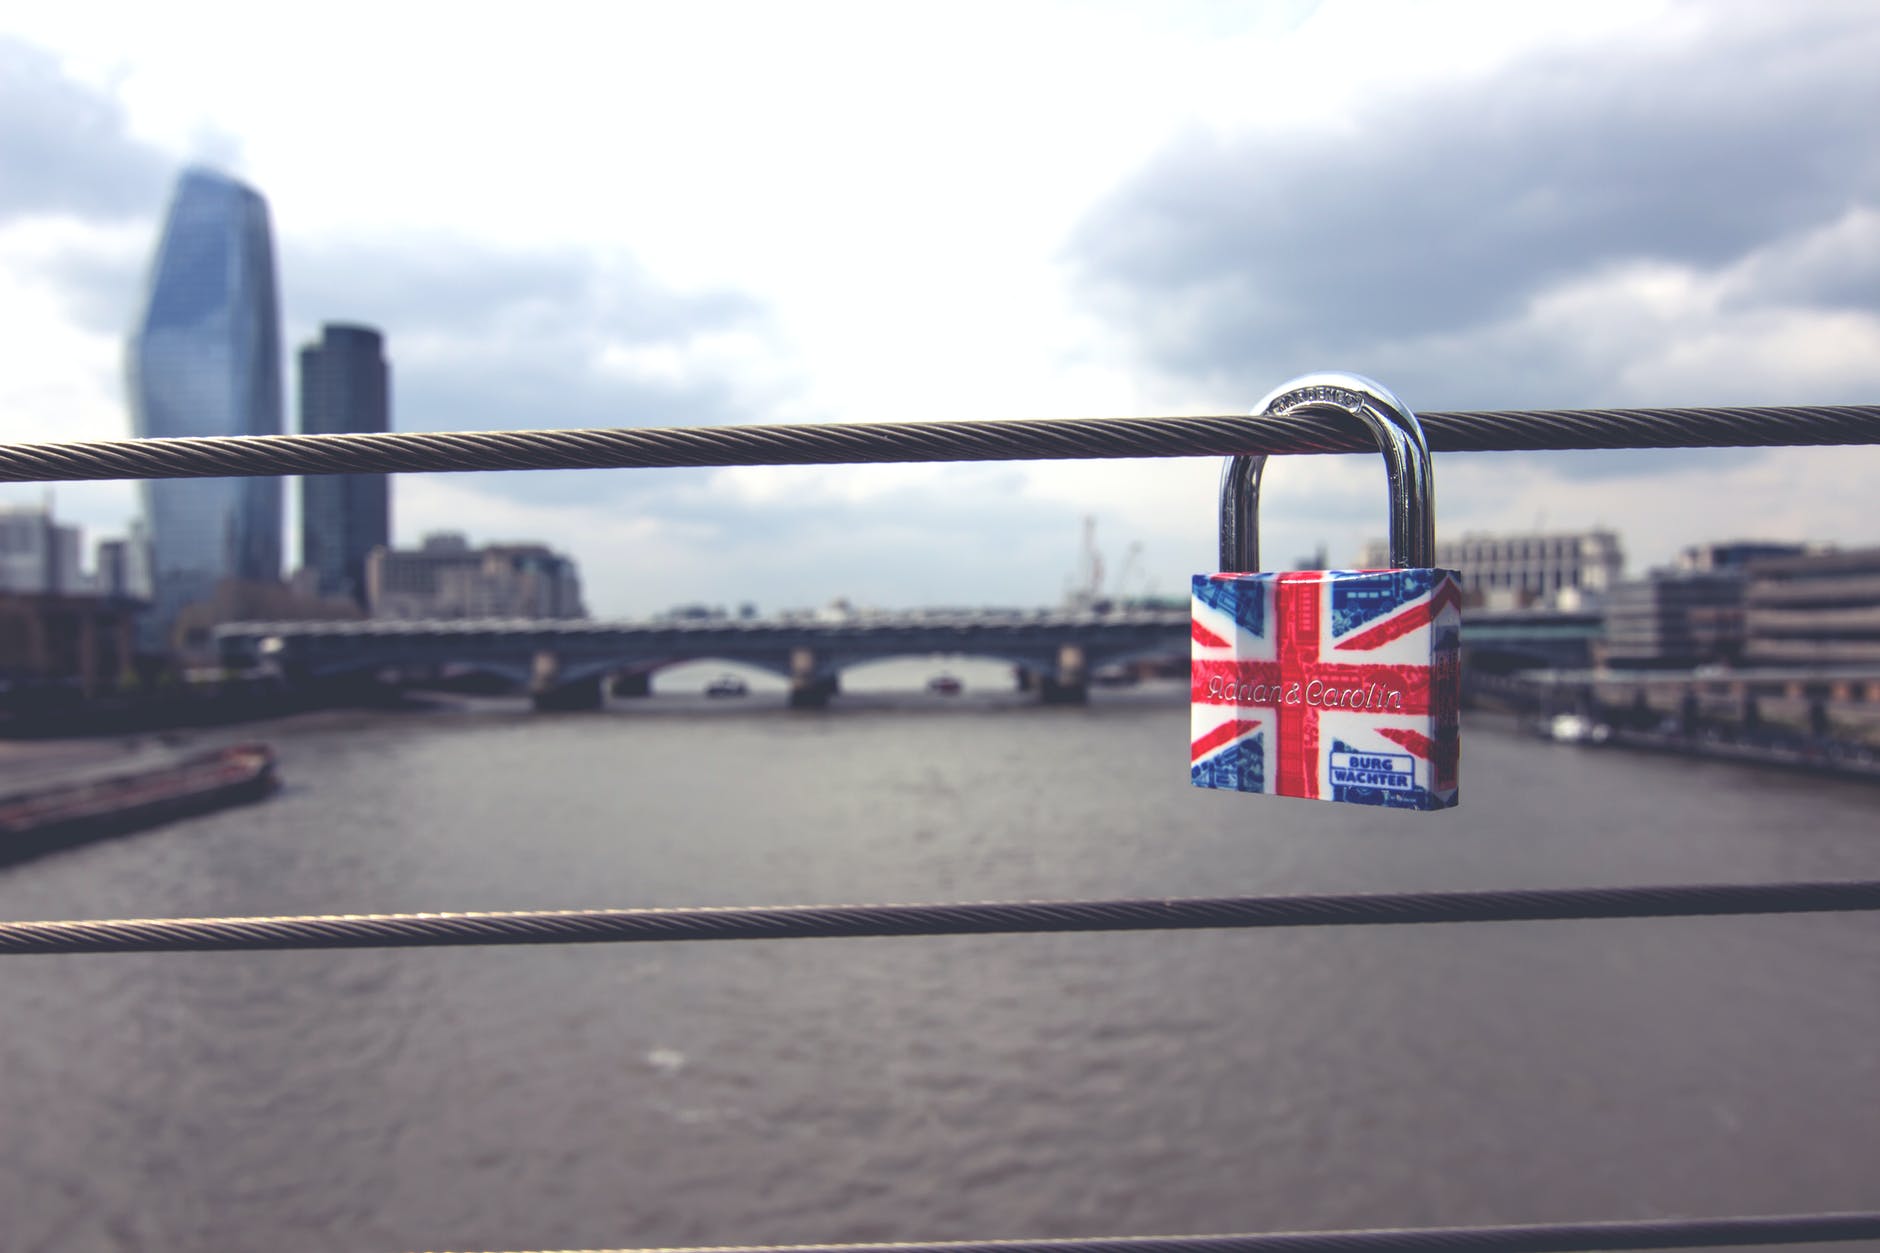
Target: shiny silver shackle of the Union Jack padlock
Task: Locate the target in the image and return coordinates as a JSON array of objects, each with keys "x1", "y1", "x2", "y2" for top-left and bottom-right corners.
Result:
[{"x1": 1220, "y1": 371, "x2": 1436, "y2": 574}]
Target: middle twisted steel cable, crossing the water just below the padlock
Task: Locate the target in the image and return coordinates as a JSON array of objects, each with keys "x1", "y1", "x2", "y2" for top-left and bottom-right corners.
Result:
[{"x1": 0, "y1": 880, "x2": 1880, "y2": 954}]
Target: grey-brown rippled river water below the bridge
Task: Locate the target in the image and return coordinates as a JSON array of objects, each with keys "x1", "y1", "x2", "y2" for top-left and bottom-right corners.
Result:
[{"x1": 0, "y1": 675, "x2": 1880, "y2": 1251}]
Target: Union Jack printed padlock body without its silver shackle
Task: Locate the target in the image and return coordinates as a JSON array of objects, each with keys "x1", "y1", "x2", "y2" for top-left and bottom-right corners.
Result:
[{"x1": 1190, "y1": 570, "x2": 1463, "y2": 809}]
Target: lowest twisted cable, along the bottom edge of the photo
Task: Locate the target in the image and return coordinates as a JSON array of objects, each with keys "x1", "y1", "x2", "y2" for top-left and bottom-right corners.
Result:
[{"x1": 432, "y1": 1212, "x2": 1880, "y2": 1253}]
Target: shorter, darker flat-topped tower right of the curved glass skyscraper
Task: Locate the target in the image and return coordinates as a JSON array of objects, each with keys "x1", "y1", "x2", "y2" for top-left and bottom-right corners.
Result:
[{"x1": 301, "y1": 324, "x2": 391, "y2": 608}]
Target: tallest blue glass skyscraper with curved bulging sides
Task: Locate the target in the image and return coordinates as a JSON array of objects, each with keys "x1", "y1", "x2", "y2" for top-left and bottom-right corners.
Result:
[{"x1": 130, "y1": 169, "x2": 282, "y2": 638}]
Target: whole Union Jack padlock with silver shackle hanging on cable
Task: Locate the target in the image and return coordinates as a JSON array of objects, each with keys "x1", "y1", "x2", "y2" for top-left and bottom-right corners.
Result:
[{"x1": 1188, "y1": 374, "x2": 1463, "y2": 809}]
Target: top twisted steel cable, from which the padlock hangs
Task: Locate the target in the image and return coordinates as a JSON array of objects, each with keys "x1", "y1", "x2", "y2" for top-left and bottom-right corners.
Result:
[{"x1": 0, "y1": 404, "x2": 1880, "y2": 484}]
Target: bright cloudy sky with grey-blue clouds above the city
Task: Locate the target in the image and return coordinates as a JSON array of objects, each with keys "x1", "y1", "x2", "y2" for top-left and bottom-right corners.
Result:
[{"x1": 0, "y1": 0, "x2": 1880, "y2": 613}]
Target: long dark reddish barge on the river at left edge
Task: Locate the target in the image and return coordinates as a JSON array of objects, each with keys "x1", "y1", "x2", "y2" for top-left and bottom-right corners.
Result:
[{"x1": 0, "y1": 743, "x2": 278, "y2": 862}]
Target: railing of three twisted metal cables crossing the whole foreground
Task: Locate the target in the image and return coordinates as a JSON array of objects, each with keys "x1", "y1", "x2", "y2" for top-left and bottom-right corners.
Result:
[{"x1": 0, "y1": 404, "x2": 1880, "y2": 1253}]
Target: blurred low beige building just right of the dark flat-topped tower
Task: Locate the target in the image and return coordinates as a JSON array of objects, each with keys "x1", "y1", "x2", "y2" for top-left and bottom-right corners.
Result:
[{"x1": 367, "y1": 532, "x2": 587, "y2": 621}]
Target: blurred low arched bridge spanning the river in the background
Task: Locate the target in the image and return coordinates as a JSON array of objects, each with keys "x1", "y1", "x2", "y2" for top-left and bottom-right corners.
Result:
[{"x1": 216, "y1": 610, "x2": 1188, "y2": 709}]
